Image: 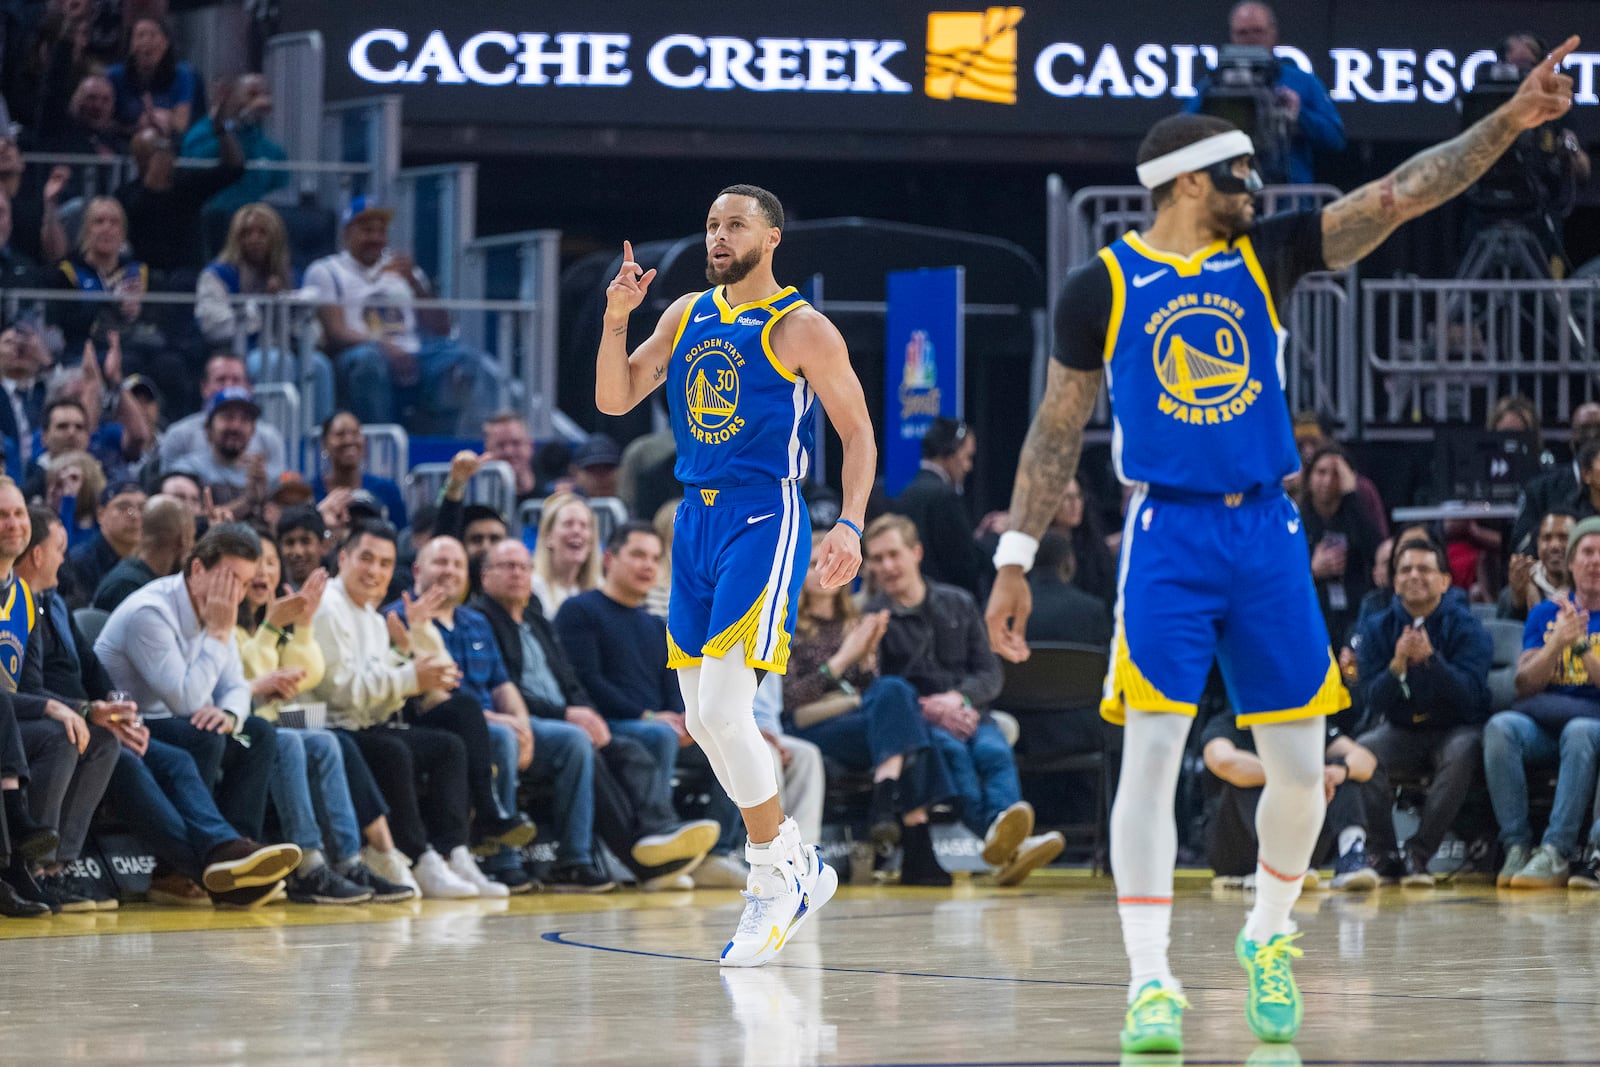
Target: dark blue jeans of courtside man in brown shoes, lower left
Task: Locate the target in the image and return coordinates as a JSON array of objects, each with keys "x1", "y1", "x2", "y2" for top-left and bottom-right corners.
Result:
[{"x1": 106, "y1": 737, "x2": 238, "y2": 881}]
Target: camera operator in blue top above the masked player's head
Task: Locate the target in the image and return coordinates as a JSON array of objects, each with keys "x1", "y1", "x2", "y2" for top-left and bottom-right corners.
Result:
[{"x1": 1184, "y1": 0, "x2": 1344, "y2": 186}]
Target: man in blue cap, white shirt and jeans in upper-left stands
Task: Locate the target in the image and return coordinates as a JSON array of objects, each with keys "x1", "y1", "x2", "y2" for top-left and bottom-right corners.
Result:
[{"x1": 306, "y1": 197, "x2": 496, "y2": 437}]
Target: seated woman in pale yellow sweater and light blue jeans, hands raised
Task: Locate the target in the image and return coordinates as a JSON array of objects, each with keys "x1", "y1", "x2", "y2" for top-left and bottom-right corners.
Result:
[{"x1": 234, "y1": 537, "x2": 416, "y2": 904}]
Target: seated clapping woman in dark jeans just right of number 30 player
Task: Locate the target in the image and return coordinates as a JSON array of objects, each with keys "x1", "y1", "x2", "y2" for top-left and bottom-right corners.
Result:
[{"x1": 784, "y1": 534, "x2": 955, "y2": 886}]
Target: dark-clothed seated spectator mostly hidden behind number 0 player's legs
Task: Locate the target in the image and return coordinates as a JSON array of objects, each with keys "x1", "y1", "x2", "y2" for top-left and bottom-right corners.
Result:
[{"x1": 1200, "y1": 713, "x2": 1390, "y2": 891}]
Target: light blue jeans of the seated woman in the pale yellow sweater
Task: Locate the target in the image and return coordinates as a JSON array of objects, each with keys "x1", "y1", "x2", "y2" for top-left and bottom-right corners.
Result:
[{"x1": 270, "y1": 726, "x2": 362, "y2": 861}]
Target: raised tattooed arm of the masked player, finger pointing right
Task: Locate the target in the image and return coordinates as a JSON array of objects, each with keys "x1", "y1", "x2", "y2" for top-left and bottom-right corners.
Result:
[{"x1": 1322, "y1": 37, "x2": 1578, "y2": 270}]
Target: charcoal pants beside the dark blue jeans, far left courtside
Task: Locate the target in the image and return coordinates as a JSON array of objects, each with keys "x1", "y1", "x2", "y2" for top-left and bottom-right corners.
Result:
[{"x1": 19, "y1": 718, "x2": 118, "y2": 864}]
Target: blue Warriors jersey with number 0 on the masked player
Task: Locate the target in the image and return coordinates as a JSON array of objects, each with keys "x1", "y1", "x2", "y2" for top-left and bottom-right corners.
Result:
[{"x1": 1099, "y1": 234, "x2": 1299, "y2": 494}]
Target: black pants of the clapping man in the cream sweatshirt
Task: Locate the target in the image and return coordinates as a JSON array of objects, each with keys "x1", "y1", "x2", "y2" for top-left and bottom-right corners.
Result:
[{"x1": 339, "y1": 726, "x2": 470, "y2": 859}]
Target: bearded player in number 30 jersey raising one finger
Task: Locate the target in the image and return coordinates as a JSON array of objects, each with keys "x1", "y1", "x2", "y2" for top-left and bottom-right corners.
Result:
[{"x1": 595, "y1": 186, "x2": 877, "y2": 966}]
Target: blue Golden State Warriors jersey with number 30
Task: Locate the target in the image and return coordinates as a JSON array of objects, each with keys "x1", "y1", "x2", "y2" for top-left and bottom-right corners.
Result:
[{"x1": 667, "y1": 285, "x2": 816, "y2": 486}]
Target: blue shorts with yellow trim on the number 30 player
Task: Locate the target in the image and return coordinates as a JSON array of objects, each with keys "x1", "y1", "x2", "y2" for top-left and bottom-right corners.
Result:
[{"x1": 667, "y1": 482, "x2": 811, "y2": 673}]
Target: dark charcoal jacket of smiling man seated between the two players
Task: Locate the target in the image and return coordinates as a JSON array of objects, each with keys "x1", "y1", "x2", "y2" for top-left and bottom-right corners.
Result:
[{"x1": 866, "y1": 582, "x2": 1005, "y2": 709}]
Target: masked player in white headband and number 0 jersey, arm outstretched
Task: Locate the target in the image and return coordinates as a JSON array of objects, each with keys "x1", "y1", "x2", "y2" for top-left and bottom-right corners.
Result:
[{"x1": 987, "y1": 37, "x2": 1578, "y2": 1053}]
